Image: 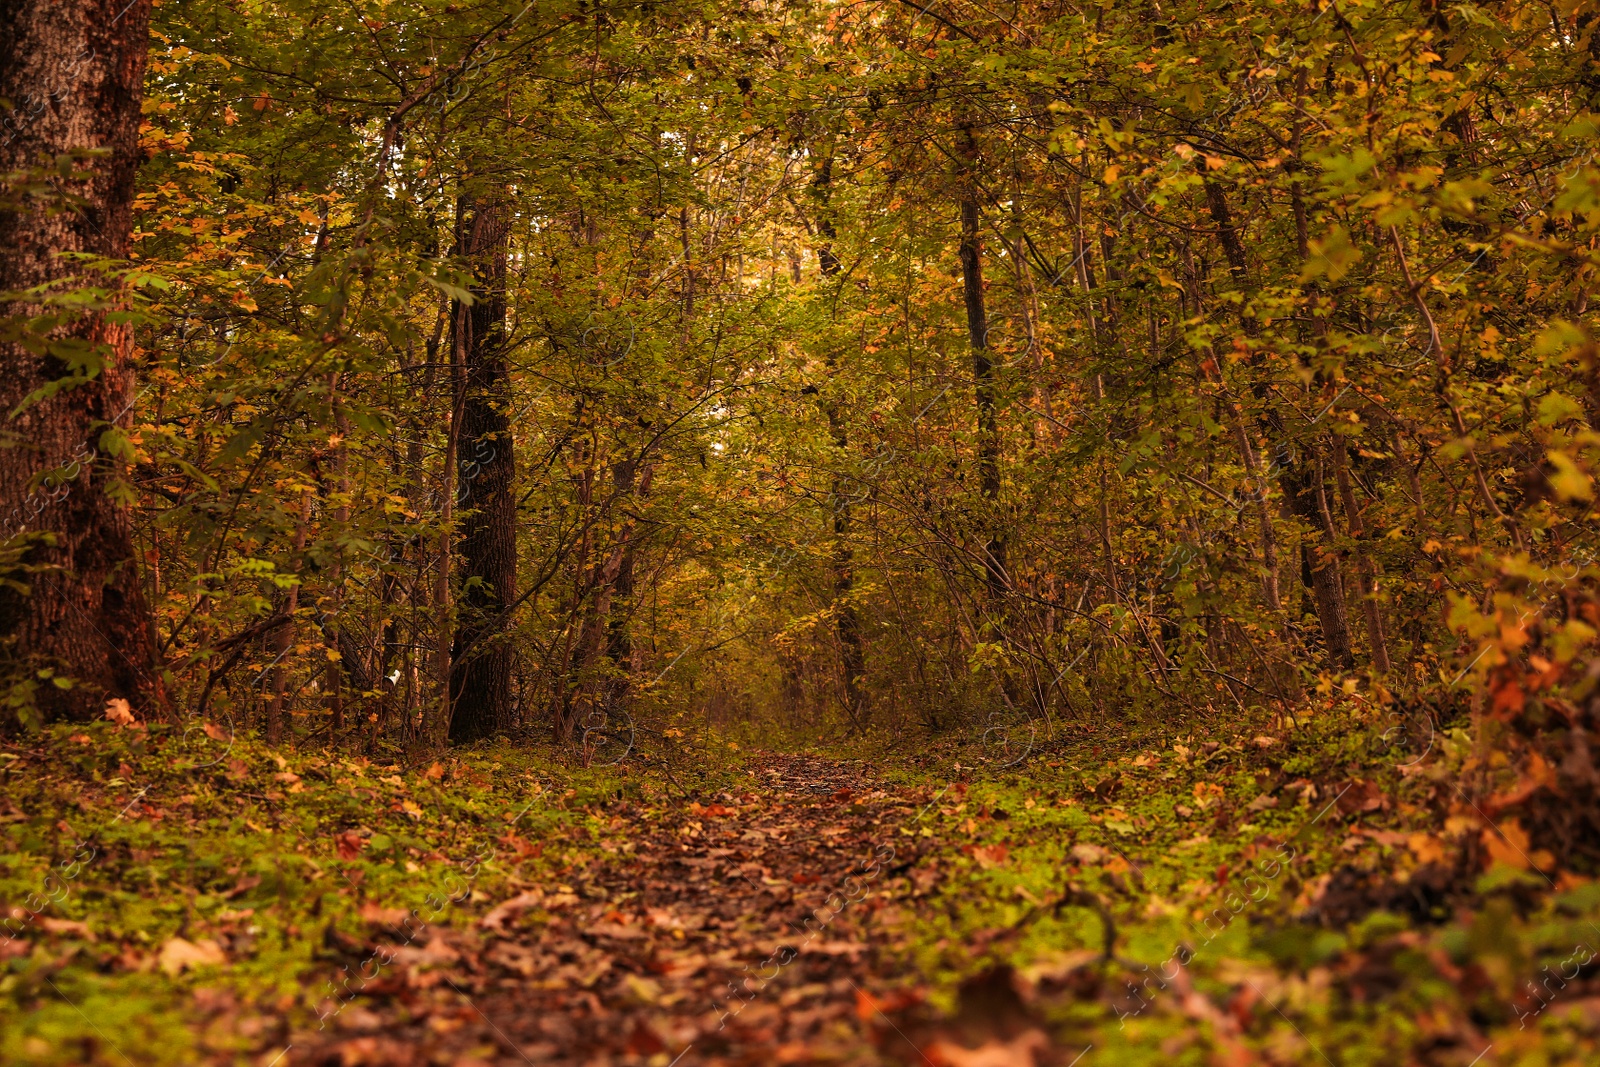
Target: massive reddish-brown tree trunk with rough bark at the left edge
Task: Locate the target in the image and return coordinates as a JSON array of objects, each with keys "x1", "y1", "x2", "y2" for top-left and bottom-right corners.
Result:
[{"x1": 0, "y1": 0, "x2": 166, "y2": 718}]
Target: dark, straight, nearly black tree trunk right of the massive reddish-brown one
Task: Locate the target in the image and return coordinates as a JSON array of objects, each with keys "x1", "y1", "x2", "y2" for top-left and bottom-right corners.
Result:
[{"x1": 450, "y1": 197, "x2": 517, "y2": 741}]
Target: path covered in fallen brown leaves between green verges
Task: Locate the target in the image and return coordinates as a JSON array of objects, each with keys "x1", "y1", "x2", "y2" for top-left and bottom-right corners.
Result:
[{"x1": 291, "y1": 755, "x2": 938, "y2": 1067}]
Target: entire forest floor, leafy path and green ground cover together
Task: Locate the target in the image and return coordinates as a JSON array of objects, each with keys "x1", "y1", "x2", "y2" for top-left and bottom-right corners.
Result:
[{"x1": 0, "y1": 718, "x2": 1600, "y2": 1067}]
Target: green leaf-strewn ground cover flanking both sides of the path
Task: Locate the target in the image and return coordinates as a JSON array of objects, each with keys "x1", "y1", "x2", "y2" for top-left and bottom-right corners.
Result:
[{"x1": 0, "y1": 703, "x2": 1600, "y2": 1067}]
